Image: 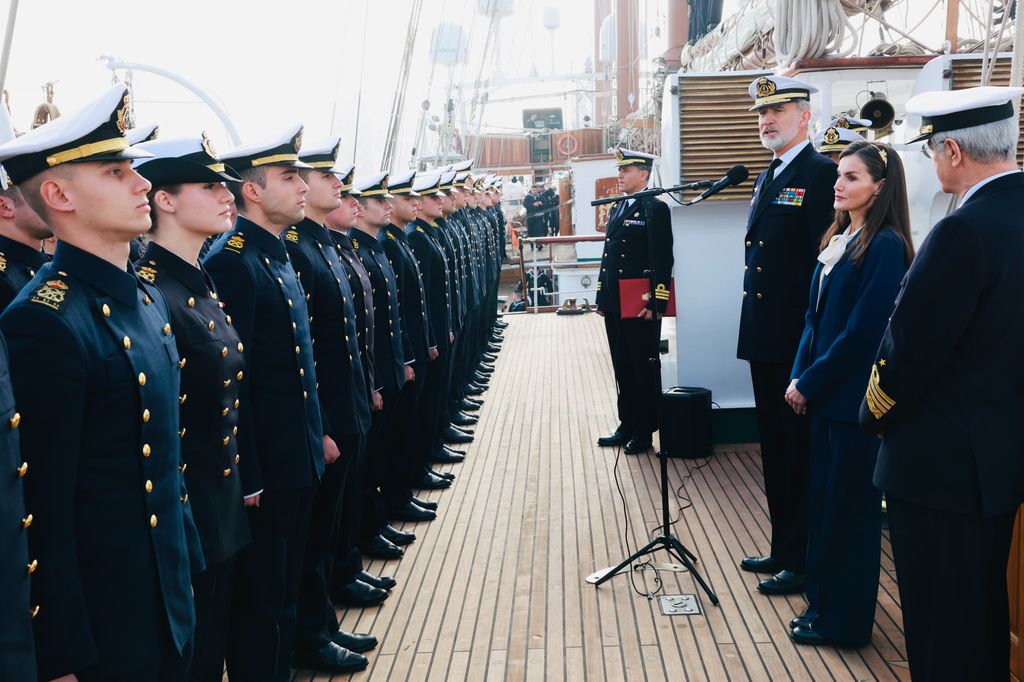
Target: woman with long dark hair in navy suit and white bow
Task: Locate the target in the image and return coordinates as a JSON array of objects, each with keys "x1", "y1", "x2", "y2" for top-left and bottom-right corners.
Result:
[{"x1": 785, "y1": 141, "x2": 913, "y2": 646}]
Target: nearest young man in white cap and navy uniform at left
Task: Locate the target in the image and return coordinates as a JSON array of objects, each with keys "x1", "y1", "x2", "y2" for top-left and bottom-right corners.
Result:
[{"x1": 0, "y1": 84, "x2": 204, "y2": 682}]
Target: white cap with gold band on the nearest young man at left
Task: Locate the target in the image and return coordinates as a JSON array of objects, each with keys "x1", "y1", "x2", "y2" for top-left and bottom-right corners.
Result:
[{"x1": 0, "y1": 83, "x2": 147, "y2": 184}]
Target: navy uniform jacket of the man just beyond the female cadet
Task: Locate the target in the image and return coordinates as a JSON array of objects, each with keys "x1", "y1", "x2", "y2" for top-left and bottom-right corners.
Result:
[{"x1": 205, "y1": 216, "x2": 324, "y2": 495}]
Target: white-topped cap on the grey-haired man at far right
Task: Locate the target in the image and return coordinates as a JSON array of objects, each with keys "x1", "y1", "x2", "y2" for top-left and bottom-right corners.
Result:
[{"x1": 906, "y1": 85, "x2": 1024, "y2": 142}]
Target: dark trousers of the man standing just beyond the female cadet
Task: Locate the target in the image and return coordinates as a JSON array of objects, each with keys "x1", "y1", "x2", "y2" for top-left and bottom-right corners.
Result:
[{"x1": 227, "y1": 487, "x2": 314, "y2": 682}]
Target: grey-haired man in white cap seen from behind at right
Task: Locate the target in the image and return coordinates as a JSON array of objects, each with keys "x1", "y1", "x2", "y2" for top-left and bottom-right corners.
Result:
[{"x1": 860, "y1": 87, "x2": 1024, "y2": 680}]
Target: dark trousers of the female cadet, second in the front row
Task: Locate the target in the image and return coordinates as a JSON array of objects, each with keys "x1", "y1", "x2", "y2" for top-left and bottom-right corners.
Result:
[{"x1": 188, "y1": 556, "x2": 234, "y2": 682}]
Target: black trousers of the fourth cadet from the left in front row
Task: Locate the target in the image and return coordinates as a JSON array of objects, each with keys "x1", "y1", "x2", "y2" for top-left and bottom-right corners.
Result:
[{"x1": 295, "y1": 434, "x2": 361, "y2": 651}]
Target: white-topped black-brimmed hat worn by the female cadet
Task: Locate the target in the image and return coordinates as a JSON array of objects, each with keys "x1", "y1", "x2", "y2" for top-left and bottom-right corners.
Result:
[{"x1": 133, "y1": 132, "x2": 242, "y2": 187}]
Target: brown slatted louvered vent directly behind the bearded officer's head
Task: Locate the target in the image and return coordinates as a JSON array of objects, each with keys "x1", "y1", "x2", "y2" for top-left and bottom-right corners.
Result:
[{"x1": 679, "y1": 73, "x2": 771, "y2": 201}]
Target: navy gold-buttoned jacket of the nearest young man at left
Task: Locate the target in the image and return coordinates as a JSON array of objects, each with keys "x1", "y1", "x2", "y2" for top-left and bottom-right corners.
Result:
[{"x1": 0, "y1": 243, "x2": 204, "y2": 680}]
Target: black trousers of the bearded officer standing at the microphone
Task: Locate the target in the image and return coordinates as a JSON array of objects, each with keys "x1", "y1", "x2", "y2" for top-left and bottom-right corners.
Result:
[{"x1": 751, "y1": 363, "x2": 810, "y2": 573}]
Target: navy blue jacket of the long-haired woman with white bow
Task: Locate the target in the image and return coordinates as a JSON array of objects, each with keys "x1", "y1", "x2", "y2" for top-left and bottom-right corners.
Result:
[{"x1": 792, "y1": 229, "x2": 906, "y2": 423}]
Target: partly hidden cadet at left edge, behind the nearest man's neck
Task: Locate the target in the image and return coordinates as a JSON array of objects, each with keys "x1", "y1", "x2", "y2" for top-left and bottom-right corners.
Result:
[{"x1": 0, "y1": 178, "x2": 53, "y2": 311}]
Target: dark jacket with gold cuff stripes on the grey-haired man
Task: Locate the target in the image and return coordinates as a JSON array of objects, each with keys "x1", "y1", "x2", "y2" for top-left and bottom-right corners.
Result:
[{"x1": 860, "y1": 172, "x2": 1024, "y2": 516}]
